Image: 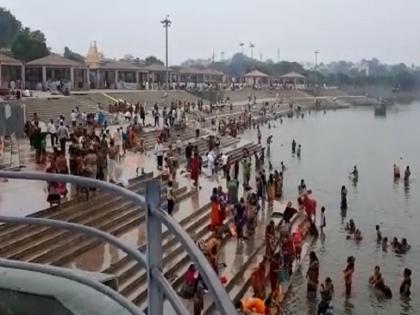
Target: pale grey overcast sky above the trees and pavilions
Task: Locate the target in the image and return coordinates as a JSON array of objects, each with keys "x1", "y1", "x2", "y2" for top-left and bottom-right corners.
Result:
[{"x1": 0, "y1": 0, "x2": 420, "y2": 64}]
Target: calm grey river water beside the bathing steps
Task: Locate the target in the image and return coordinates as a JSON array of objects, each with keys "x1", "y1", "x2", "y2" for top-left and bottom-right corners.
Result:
[{"x1": 243, "y1": 102, "x2": 420, "y2": 315}]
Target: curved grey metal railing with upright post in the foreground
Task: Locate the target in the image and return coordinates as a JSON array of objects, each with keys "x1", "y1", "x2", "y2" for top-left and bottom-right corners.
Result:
[{"x1": 0, "y1": 171, "x2": 237, "y2": 315}]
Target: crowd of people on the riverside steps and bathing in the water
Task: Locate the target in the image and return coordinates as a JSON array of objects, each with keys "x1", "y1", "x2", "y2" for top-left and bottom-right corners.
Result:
[{"x1": 18, "y1": 94, "x2": 412, "y2": 315}]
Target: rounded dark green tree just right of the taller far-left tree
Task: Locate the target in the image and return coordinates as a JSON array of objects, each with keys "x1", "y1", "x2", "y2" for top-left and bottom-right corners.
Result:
[{"x1": 12, "y1": 27, "x2": 50, "y2": 61}]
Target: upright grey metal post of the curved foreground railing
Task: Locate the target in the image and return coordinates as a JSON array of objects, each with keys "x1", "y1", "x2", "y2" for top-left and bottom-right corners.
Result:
[{"x1": 146, "y1": 180, "x2": 163, "y2": 315}]
